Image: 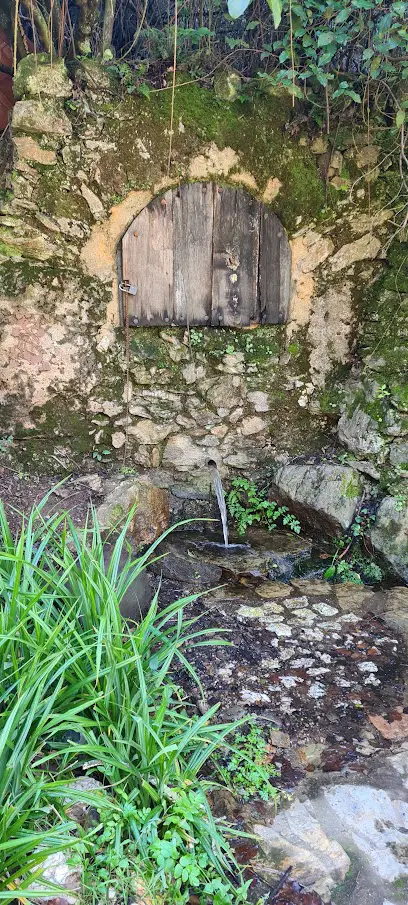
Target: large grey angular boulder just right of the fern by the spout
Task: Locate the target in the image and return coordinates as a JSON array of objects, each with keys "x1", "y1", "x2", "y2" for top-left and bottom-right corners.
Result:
[{"x1": 271, "y1": 463, "x2": 362, "y2": 534}]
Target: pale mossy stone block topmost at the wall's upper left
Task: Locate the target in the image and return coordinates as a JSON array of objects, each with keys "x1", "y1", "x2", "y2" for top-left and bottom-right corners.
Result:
[{"x1": 13, "y1": 53, "x2": 72, "y2": 100}]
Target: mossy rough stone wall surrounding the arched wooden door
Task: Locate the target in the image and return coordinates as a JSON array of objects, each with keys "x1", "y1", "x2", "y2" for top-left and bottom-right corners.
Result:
[{"x1": 0, "y1": 57, "x2": 406, "y2": 494}]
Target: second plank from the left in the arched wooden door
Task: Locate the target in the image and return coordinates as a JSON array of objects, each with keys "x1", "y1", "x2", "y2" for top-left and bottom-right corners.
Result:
[{"x1": 173, "y1": 182, "x2": 214, "y2": 325}]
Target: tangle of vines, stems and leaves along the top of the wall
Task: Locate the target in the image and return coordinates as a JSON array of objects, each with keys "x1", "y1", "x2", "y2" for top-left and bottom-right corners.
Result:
[{"x1": 0, "y1": 0, "x2": 408, "y2": 128}]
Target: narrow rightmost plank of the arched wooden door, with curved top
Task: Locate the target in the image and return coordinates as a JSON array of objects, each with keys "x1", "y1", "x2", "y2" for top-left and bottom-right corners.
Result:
[{"x1": 259, "y1": 207, "x2": 291, "y2": 324}]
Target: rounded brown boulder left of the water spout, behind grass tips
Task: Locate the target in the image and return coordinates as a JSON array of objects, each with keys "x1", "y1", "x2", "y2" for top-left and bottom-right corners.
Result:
[{"x1": 97, "y1": 478, "x2": 170, "y2": 546}]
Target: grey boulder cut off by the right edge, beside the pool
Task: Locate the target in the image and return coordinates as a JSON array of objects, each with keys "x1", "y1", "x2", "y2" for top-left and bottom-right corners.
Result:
[{"x1": 370, "y1": 497, "x2": 408, "y2": 581}]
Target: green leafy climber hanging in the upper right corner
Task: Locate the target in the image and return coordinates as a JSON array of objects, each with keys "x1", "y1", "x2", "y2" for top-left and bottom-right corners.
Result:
[{"x1": 228, "y1": 0, "x2": 408, "y2": 126}]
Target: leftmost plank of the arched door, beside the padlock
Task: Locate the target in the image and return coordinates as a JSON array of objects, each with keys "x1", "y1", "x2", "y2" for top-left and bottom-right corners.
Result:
[{"x1": 122, "y1": 191, "x2": 174, "y2": 326}]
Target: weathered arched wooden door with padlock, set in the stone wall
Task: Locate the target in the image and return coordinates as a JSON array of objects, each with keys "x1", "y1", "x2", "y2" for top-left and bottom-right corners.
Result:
[{"x1": 122, "y1": 182, "x2": 291, "y2": 327}]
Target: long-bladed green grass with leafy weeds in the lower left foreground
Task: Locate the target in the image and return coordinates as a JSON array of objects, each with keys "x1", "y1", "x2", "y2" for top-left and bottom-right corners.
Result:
[{"x1": 0, "y1": 500, "x2": 255, "y2": 905}]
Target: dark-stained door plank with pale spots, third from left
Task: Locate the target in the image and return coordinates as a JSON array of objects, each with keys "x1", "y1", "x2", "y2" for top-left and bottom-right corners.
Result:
[{"x1": 212, "y1": 186, "x2": 259, "y2": 327}]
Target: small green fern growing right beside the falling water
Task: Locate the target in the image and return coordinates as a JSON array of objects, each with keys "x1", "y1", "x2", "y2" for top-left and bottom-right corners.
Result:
[{"x1": 227, "y1": 478, "x2": 301, "y2": 535}]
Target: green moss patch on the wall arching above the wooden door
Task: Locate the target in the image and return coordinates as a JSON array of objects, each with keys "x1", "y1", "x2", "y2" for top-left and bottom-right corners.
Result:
[{"x1": 67, "y1": 85, "x2": 324, "y2": 230}]
